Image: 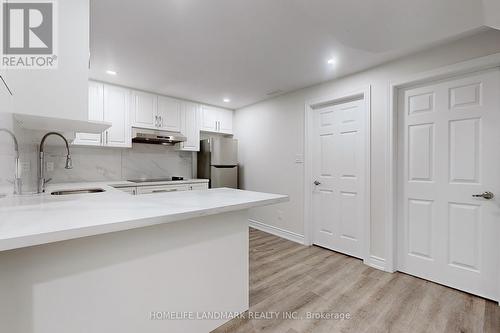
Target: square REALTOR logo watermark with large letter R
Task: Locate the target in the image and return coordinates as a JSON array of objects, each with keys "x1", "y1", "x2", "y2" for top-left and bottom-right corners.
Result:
[{"x1": 0, "y1": 0, "x2": 57, "y2": 69}]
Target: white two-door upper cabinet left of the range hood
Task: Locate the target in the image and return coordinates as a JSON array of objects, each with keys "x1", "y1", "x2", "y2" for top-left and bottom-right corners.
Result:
[{"x1": 73, "y1": 81, "x2": 132, "y2": 148}]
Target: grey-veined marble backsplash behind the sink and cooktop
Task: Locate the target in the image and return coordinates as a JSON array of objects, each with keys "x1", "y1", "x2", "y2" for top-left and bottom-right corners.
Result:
[{"x1": 0, "y1": 138, "x2": 193, "y2": 193}]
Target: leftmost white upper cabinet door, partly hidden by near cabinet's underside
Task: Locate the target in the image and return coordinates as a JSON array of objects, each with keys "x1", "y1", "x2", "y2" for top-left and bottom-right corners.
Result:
[{"x1": 73, "y1": 81, "x2": 104, "y2": 146}]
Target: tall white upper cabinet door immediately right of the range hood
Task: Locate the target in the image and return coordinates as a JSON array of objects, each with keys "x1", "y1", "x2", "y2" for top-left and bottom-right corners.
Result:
[{"x1": 179, "y1": 102, "x2": 200, "y2": 151}]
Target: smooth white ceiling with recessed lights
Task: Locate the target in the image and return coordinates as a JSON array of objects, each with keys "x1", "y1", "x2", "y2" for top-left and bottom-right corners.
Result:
[{"x1": 91, "y1": 0, "x2": 492, "y2": 108}]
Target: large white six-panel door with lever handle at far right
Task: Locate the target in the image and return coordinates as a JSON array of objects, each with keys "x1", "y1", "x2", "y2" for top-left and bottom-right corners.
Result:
[{"x1": 398, "y1": 70, "x2": 500, "y2": 299}]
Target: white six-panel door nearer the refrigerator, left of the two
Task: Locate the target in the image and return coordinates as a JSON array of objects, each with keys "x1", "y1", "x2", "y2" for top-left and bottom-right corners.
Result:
[{"x1": 312, "y1": 100, "x2": 367, "y2": 258}]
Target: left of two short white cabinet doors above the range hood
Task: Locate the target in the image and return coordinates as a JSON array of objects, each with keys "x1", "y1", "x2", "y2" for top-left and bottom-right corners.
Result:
[{"x1": 132, "y1": 91, "x2": 158, "y2": 129}]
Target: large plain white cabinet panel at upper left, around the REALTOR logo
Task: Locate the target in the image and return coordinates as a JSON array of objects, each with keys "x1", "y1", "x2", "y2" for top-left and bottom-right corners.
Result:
[{"x1": 0, "y1": 0, "x2": 89, "y2": 120}]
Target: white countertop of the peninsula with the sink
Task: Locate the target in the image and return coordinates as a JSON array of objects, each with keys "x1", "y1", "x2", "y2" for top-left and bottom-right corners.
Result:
[{"x1": 0, "y1": 182, "x2": 288, "y2": 251}]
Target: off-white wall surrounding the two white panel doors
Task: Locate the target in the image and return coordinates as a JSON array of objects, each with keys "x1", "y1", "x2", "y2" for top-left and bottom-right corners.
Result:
[{"x1": 234, "y1": 30, "x2": 500, "y2": 258}]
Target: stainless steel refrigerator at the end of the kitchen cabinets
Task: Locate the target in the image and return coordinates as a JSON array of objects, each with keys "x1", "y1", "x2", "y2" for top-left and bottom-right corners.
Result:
[{"x1": 198, "y1": 138, "x2": 238, "y2": 188}]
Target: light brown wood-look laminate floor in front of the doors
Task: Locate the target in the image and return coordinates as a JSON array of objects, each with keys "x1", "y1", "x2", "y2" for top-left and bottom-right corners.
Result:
[{"x1": 213, "y1": 229, "x2": 500, "y2": 333}]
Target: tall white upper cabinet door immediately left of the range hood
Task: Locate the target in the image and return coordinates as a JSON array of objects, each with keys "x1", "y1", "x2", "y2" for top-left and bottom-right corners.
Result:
[{"x1": 104, "y1": 85, "x2": 132, "y2": 148}]
